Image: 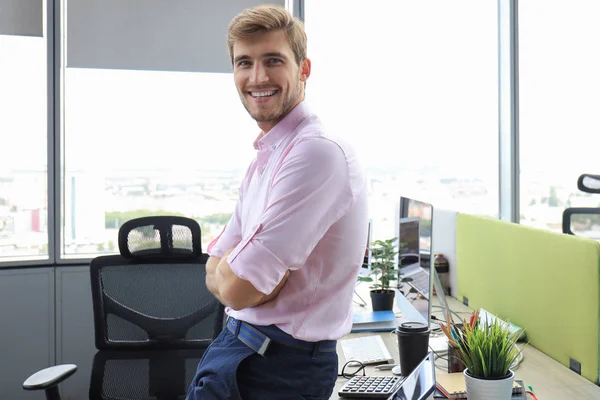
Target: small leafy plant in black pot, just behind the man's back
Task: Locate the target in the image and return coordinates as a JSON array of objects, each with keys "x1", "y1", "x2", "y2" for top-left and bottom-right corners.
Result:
[{"x1": 359, "y1": 237, "x2": 398, "y2": 311}]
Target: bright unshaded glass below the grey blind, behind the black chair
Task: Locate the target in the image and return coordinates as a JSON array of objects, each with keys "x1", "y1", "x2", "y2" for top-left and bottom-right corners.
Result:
[{"x1": 64, "y1": 68, "x2": 256, "y2": 257}]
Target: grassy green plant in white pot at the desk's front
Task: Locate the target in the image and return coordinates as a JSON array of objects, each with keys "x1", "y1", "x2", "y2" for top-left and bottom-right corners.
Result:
[{"x1": 440, "y1": 311, "x2": 522, "y2": 400}]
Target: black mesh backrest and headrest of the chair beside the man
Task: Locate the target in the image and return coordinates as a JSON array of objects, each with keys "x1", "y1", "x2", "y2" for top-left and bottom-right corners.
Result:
[{"x1": 90, "y1": 216, "x2": 223, "y2": 350}]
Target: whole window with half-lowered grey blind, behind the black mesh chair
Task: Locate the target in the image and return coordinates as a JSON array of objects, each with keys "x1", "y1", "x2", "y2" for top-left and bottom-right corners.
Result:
[{"x1": 61, "y1": 0, "x2": 278, "y2": 259}]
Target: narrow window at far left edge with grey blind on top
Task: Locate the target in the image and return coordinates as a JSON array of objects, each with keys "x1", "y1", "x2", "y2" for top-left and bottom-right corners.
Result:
[{"x1": 0, "y1": 1, "x2": 48, "y2": 262}]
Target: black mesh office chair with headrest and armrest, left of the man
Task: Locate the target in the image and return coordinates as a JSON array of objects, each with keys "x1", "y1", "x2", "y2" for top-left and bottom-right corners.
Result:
[{"x1": 23, "y1": 216, "x2": 224, "y2": 400}]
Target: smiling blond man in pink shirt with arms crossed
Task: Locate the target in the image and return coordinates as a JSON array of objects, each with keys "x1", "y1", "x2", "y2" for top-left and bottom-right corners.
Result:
[{"x1": 188, "y1": 6, "x2": 368, "y2": 400}]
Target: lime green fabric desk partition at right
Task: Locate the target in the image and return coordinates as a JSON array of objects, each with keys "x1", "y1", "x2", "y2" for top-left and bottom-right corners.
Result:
[{"x1": 456, "y1": 214, "x2": 600, "y2": 383}]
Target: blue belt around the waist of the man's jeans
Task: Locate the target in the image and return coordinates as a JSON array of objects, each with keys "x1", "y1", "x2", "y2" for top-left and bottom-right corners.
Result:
[{"x1": 227, "y1": 317, "x2": 337, "y2": 356}]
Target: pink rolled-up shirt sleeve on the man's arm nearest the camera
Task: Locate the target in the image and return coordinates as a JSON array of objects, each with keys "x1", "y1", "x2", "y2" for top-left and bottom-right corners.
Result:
[{"x1": 227, "y1": 137, "x2": 354, "y2": 294}]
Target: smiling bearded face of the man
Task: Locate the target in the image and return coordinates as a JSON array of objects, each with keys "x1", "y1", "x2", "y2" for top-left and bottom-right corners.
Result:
[{"x1": 233, "y1": 31, "x2": 310, "y2": 132}]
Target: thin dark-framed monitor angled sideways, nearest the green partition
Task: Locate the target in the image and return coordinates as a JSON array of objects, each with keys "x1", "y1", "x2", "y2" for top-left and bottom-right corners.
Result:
[{"x1": 396, "y1": 197, "x2": 433, "y2": 324}]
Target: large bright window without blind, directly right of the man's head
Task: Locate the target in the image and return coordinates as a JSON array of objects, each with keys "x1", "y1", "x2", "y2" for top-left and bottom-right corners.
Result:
[{"x1": 306, "y1": 0, "x2": 498, "y2": 237}]
